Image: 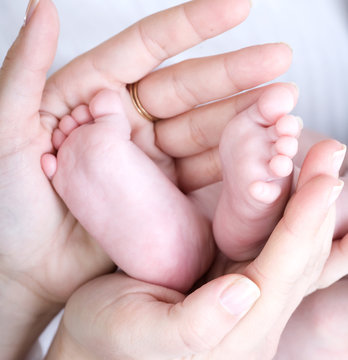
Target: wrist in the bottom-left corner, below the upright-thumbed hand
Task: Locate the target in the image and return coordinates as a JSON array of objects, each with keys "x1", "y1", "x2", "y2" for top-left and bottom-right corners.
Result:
[{"x1": 0, "y1": 274, "x2": 62, "y2": 360}]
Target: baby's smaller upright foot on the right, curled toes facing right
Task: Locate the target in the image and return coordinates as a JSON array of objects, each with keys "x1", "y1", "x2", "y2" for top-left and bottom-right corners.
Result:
[{"x1": 213, "y1": 86, "x2": 302, "y2": 260}]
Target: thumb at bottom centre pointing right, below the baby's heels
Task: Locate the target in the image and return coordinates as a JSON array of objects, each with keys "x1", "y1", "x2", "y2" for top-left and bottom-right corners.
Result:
[{"x1": 125, "y1": 274, "x2": 260, "y2": 360}]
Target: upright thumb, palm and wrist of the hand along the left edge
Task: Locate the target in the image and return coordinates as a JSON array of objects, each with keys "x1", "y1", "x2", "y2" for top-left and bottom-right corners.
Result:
[{"x1": 0, "y1": 0, "x2": 114, "y2": 360}]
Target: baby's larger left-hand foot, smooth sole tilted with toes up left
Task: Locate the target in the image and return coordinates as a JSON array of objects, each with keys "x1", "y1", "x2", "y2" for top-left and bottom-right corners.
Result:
[{"x1": 42, "y1": 90, "x2": 214, "y2": 291}]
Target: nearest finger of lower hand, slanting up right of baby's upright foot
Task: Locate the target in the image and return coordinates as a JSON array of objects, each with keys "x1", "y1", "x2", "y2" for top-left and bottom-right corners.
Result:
[{"x1": 249, "y1": 175, "x2": 342, "y2": 284}]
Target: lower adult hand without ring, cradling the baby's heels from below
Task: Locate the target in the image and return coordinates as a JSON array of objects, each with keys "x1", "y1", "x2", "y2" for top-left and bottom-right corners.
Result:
[{"x1": 47, "y1": 141, "x2": 347, "y2": 360}]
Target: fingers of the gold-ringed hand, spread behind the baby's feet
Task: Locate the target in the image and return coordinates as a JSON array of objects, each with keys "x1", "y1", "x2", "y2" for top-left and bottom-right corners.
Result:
[{"x1": 41, "y1": 0, "x2": 296, "y2": 192}]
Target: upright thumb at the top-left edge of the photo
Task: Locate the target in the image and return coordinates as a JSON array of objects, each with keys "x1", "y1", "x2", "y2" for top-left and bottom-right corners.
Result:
[{"x1": 0, "y1": 0, "x2": 59, "y2": 135}]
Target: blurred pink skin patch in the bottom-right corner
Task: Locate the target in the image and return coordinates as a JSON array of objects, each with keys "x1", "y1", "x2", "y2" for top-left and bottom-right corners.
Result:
[{"x1": 275, "y1": 279, "x2": 348, "y2": 360}]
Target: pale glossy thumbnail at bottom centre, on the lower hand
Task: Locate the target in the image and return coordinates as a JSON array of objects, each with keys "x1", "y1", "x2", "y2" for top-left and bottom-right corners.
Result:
[{"x1": 220, "y1": 278, "x2": 260, "y2": 319}]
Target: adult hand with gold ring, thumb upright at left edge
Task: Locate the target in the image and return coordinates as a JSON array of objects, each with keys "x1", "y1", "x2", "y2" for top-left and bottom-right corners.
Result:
[{"x1": 0, "y1": 0, "x2": 291, "y2": 358}]
